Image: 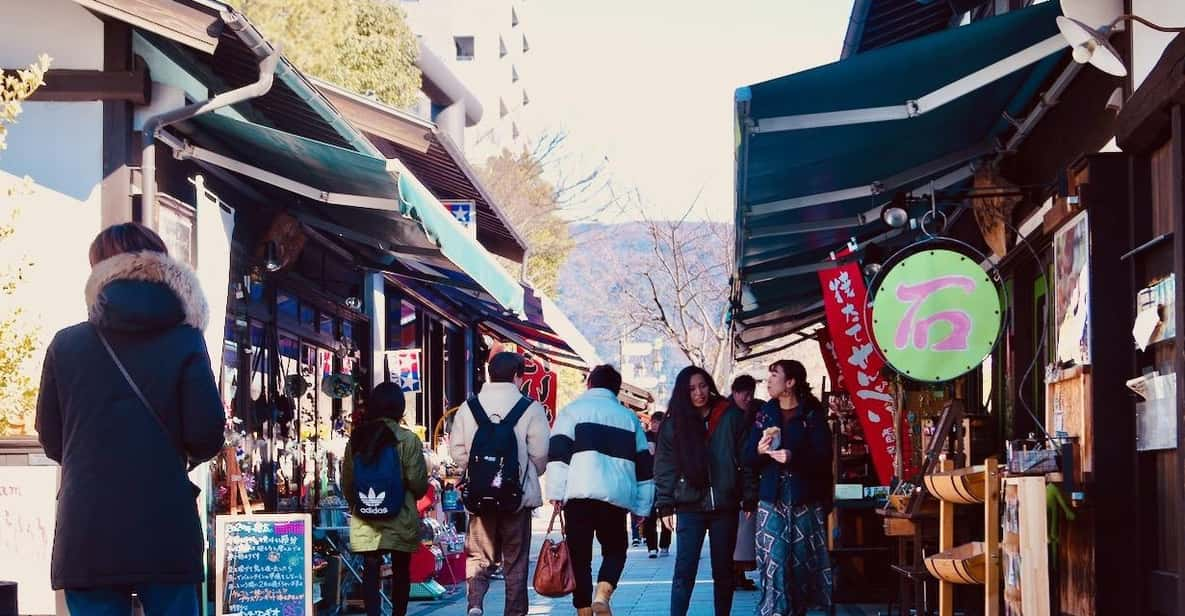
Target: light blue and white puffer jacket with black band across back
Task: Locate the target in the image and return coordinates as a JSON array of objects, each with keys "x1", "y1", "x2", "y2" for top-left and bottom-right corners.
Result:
[{"x1": 546, "y1": 389, "x2": 654, "y2": 516}]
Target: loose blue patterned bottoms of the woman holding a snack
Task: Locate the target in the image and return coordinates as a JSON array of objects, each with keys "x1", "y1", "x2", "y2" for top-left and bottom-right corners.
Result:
[{"x1": 757, "y1": 482, "x2": 832, "y2": 616}]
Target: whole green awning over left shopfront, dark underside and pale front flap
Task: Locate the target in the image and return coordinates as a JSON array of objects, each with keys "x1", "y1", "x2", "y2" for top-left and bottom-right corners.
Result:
[{"x1": 171, "y1": 114, "x2": 524, "y2": 314}]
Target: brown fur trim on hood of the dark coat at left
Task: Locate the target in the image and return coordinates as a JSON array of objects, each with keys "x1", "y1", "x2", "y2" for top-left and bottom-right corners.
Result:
[{"x1": 87, "y1": 251, "x2": 210, "y2": 331}]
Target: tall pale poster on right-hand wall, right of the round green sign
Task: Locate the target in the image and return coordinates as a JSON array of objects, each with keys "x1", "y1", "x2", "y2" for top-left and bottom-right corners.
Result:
[{"x1": 1053, "y1": 212, "x2": 1090, "y2": 365}]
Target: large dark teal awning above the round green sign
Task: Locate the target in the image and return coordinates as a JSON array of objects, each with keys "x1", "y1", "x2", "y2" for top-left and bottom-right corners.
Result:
[{"x1": 732, "y1": 2, "x2": 1068, "y2": 347}]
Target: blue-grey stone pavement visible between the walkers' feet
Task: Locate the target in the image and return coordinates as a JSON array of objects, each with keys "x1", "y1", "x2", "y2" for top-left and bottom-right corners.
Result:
[{"x1": 395, "y1": 531, "x2": 877, "y2": 616}]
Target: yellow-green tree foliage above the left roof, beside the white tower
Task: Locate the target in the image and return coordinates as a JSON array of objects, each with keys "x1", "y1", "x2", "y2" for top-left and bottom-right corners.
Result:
[{"x1": 230, "y1": 0, "x2": 421, "y2": 107}]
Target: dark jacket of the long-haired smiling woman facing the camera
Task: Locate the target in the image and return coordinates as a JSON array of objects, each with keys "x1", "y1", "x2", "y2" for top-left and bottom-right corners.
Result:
[{"x1": 654, "y1": 408, "x2": 756, "y2": 512}]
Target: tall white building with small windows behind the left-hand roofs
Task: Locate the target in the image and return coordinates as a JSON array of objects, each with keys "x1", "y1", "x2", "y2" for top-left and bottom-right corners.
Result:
[{"x1": 399, "y1": 0, "x2": 531, "y2": 160}]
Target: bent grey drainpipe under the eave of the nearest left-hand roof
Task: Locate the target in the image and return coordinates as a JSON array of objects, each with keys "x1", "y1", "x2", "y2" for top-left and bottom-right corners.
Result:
[{"x1": 140, "y1": 11, "x2": 280, "y2": 225}]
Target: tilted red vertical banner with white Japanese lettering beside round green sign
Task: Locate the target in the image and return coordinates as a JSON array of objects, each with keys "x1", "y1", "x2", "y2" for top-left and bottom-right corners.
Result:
[{"x1": 819, "y1": 263, "x2": 914, "y2": 486}]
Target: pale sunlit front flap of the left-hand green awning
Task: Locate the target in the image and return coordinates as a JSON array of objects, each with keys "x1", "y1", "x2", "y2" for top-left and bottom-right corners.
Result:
[{"x1": 399, "y1": 165, "x2": 525, "y2": 315}]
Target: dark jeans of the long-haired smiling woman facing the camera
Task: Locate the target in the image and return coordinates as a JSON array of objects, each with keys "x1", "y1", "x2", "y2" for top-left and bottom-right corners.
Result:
[{"x1": 671, "y1": 511, "x2": 737, "y2": 616}]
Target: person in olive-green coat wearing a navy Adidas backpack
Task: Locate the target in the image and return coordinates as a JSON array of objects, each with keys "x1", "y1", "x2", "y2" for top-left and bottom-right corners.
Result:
[{"x1": 341, "y1": 383, "x2": 428, "y2": 616}]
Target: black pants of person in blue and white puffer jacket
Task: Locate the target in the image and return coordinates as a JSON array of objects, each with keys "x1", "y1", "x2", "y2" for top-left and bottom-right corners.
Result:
[{"x1": 564, "y1": 500, "x2": 629, "y2": 609}]
